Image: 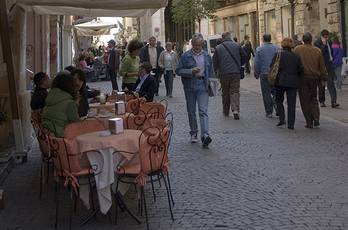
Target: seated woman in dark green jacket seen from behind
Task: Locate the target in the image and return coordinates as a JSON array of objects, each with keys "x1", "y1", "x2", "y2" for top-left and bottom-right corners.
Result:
[{"x1": 42, "y1": 73, "x2": 81, "y2": 137}]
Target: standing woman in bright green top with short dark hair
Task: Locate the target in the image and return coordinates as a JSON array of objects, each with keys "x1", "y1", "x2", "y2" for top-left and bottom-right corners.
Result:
[{"x1": 120, "y1": 39, "x2": 143, "y2": 91}]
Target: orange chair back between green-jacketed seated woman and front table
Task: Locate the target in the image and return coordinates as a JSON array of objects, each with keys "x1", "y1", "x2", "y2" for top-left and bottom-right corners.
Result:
[{"x1": 64, "y1": 119, "x2": 105, "y2": 142}]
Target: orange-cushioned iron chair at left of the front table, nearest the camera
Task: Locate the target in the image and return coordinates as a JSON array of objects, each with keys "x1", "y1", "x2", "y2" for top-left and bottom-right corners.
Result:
[{"x1": 49, "y1": 135, "x2": 100, "y2": 229}]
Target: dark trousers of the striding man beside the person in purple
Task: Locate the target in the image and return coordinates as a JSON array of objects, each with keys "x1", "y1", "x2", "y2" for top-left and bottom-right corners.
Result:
[{"x1": 318, "y1": 62, "x2": 337, "y2": 103}]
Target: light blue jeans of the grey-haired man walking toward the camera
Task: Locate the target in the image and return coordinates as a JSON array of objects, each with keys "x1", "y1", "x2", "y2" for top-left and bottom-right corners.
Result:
[{"x1": 185, "y1": 80, "x2": 209, "y2": 138}]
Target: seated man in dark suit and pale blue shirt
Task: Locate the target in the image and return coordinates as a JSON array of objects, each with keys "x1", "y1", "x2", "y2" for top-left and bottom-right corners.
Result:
[{"x1": 135, "y1": 62, "x2": 157, "y2": 102}]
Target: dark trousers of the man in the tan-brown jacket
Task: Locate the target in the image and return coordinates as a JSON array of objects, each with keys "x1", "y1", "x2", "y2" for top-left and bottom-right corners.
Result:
[{"x1": 299, "y1": 76, "x2": 320, "y2": 126}]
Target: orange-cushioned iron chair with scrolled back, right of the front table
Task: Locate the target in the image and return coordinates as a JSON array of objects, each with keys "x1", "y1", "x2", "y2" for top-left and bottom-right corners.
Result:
[{"x1": 115, "y1": 125, "x2": 174, "y2": 229}]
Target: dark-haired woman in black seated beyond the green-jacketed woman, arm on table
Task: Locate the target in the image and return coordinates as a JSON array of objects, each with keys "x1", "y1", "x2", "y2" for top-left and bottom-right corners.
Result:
[{"x1": 70, "y1": 69, "x2": 100, "y2": 117}]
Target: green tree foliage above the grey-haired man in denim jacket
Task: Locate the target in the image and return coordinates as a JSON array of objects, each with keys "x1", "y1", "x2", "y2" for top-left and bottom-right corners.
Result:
[{"x1": 172, "y1": 0, "x2": 217, "y2": 31}]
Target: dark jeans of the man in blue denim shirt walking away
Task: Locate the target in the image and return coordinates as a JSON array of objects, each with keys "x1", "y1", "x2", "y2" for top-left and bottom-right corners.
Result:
[{"x1": 260, "y1": 74, "x2": 275, "y2": 114}]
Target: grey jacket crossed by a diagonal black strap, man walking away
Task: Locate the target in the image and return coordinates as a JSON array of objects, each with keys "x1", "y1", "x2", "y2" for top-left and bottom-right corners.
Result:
[{"x1": 213, "y1": 38, "x2": 248, "y2": 76}]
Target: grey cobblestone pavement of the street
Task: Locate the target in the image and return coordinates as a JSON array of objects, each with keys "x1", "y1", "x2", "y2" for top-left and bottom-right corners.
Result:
[{"x1": 0, "y1": 75, "x2": 348, "y2": 230}]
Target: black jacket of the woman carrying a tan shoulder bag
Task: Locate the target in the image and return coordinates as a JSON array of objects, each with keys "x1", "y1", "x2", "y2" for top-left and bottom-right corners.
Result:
[{"x1": 270, "y1": 49, "x2": 304, "y2": 88}]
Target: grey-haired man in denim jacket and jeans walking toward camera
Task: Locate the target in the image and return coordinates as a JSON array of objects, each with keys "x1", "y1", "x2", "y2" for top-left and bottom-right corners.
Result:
[{"x1": 175, "y1": 33, "x2": 215, "y2": 147}]
